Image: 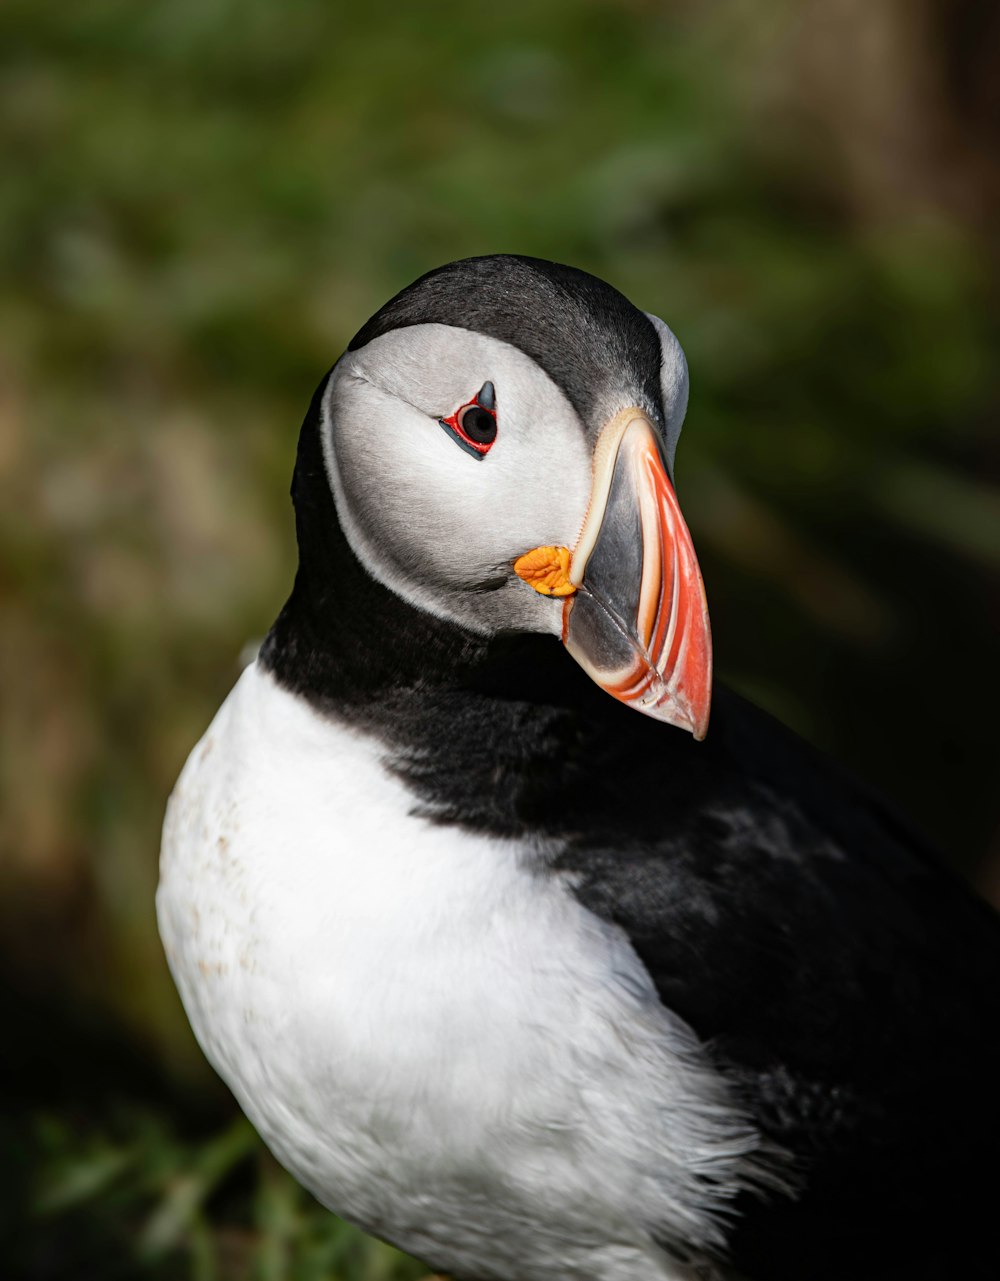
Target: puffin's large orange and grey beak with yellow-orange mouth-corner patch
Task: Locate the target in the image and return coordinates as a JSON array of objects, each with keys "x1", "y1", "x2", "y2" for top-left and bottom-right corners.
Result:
[{"x1": 515, "y1": 409, "x2": 712, "y2": 739}]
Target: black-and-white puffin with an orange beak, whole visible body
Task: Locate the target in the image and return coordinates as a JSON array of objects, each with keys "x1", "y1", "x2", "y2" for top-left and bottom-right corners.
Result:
[{"x1": 156, "y1": 255, "x2": 1000, "y2": 1281}]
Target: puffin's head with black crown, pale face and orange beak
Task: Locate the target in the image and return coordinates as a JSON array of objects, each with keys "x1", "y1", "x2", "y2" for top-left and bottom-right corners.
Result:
[{"x1": 276, "y1": 255, "x2": 712, "y2": 738}]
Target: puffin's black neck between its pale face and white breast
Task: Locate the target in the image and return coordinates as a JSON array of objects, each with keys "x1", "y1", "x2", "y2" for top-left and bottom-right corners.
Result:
[{"x1": 260, "y1": 392, "x2": 627, "y2": 830}]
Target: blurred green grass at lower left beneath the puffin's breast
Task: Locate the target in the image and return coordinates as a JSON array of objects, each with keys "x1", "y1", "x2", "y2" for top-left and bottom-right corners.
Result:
[{"x1": 16, "y1": 1111, "x2": 426, "y2": 1281}]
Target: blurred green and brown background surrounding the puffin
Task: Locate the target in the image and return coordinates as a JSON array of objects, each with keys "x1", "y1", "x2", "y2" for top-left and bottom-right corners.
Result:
[{"x1": 0, "y1": 0, "x2": 1000, "y2": 1281}]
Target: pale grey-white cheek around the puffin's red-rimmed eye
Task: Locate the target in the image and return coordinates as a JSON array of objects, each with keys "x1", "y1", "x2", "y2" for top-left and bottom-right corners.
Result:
[{"x1": 324, "y1": 327, "x2": 590, "y2": 633}]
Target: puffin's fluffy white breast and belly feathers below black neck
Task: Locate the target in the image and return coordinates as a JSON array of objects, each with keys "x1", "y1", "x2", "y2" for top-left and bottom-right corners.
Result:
[{"x1": 157, "y1": 665, "x2": 755, "y2": 1281}]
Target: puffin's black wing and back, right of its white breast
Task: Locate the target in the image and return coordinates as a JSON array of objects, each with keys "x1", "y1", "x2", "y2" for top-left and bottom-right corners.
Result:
[{"x1": 545, "y1": 690, "x2": 1000, "y2": 1281}]
